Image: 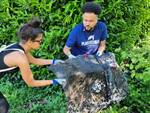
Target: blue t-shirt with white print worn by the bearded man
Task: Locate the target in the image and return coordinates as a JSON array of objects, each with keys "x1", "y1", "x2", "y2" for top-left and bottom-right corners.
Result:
[{"x1": 66, "y1": 21, "x2": 107, "y2": 56}]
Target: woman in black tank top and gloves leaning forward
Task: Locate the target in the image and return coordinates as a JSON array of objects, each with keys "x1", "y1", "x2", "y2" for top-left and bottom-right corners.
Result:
[{"x1": 0, "y1": 18, "x2": 66, "y2": 113}]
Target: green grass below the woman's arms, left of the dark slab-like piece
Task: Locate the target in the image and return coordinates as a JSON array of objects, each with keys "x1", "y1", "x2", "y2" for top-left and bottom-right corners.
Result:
[{"x1": 0, "y1": 76, "x2": 66, "y2": 113}]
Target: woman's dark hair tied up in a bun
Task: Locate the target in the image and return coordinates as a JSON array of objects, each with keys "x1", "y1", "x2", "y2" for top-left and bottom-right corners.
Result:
[{"x1": 18, "y1": 17, "x2": 44, "y2": 41}]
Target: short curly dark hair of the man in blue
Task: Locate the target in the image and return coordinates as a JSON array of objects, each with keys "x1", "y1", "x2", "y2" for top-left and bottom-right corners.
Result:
[{"x1": 81, "y1": 2, "x2": 101, "y2": 15}]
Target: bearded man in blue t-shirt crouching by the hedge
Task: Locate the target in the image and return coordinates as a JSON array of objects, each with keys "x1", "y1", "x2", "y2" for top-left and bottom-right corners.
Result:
[{"x1": 63, "y1": 2, "x2": 107, "y2": 58}]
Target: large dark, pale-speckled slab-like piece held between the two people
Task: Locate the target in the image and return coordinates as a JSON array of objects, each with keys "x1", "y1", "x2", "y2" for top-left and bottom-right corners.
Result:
[{"x1": 49, "y1": 52, "x2": 128, "y2": 113}]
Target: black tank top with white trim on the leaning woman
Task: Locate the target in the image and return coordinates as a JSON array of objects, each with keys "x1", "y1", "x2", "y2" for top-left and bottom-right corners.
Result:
[{"x1": 0, "y1": 43, "x2": 25, "y2": 75}]
